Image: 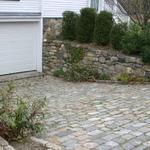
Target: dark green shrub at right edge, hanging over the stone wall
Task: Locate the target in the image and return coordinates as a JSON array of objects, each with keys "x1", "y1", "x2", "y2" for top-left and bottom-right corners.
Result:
[{"x1": 141, "y1": 46, "x2": 150, "y2": 64}]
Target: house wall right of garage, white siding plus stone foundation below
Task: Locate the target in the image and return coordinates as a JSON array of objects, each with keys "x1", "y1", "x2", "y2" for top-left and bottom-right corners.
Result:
[{"x1": 42, "y1": 0, "x2": 89, "y2": 41}]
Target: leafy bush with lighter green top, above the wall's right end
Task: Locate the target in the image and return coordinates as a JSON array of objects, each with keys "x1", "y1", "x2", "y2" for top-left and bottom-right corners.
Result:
[{"x1": 122, "y1": 24, "x2": 143, "y2": 54}]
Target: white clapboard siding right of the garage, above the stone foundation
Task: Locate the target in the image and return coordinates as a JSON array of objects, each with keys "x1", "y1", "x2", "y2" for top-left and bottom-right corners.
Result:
[{"x1": 42, "y1": 0, "x2": 88, "y2": 18}]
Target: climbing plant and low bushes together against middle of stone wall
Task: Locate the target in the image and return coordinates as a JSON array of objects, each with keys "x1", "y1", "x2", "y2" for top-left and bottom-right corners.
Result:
[{"x1": 53, "y1": 45, "x2": 110, "y2": 82}]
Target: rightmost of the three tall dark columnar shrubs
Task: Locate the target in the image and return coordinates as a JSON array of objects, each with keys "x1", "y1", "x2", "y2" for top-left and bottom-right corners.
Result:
[{"x1": 94, "y1": 11, "x2": 113, "y2": 45}]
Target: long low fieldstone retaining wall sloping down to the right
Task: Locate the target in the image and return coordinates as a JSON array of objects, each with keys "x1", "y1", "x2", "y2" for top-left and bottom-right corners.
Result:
[{"x1": 43, "y1": 40, "x2": 150, "y2": 77}]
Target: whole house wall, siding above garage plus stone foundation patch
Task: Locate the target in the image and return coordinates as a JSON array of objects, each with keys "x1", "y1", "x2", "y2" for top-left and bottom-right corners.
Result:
[{"x1": 0, "y1": 0, "x2": 89, "y2": 40}]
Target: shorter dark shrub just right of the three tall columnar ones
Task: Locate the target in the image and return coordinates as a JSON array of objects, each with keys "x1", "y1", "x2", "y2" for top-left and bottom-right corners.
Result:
[{"x1": 110, "y1": 24, "x2": 127, "y2": 50}]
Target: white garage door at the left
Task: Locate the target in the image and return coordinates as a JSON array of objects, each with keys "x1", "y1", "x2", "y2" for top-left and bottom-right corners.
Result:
[{"x1": 0, "y1": 22, "x2": 38, "y2": 75}]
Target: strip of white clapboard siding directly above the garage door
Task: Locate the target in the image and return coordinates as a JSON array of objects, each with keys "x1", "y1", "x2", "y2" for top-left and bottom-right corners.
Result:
[{"x1": 0, "y1": 0, "x2": 41, "y2": 12}]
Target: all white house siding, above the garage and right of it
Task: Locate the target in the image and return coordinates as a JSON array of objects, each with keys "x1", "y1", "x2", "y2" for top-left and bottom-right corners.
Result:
[{"x1": 0, "y1": 0, "x2": 89, "y2": 15}]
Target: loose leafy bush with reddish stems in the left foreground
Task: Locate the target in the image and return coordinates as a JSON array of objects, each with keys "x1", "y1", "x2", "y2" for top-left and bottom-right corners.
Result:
[{"x1": 0, "y1": 83, "x2": 46, "y2": 140}]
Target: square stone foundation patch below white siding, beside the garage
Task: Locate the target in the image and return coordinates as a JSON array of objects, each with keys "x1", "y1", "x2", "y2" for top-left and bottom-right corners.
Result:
[{"x1": 43, "y1": 18, "x2": 62, "y2": 41}]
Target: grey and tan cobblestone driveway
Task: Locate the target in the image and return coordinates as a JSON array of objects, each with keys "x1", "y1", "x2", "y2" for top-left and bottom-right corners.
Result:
[{"x1": 14, "y1": 76, "x2": 150, "y2": 150}]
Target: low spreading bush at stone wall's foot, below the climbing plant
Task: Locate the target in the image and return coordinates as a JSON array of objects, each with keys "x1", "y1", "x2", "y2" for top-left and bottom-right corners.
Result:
[{"x1": 65, "y1": 64, "x2": 99, "y2": 82}]
